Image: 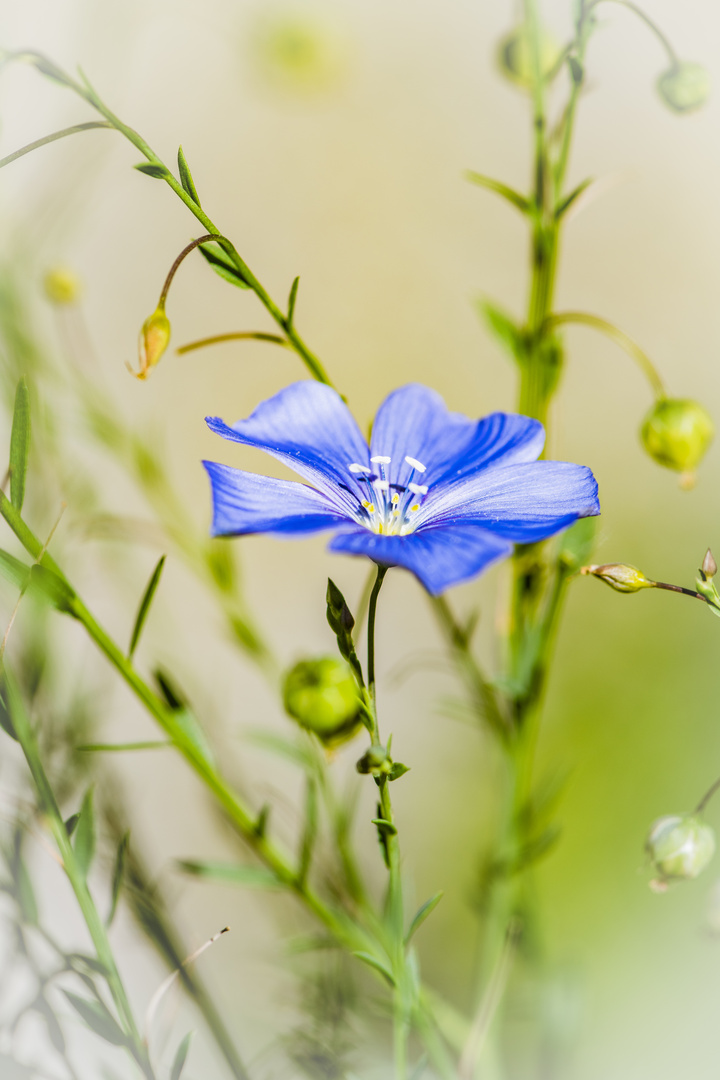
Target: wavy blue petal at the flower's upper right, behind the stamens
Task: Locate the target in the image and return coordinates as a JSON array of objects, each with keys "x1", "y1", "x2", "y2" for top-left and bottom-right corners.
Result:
[{"x1": 371, "y1": 382, "x2": 545, "y2": 486}]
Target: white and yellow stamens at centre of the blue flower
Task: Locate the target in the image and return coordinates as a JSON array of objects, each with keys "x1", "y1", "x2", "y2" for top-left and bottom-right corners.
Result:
[{"x1": 348, "y1": 455, "x2": 427, "y2": 537}]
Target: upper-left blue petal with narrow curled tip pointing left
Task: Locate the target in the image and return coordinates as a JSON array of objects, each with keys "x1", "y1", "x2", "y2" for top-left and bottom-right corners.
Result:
[{"x1": 206, "y1": 381, "x2": 369, "y2": 513}]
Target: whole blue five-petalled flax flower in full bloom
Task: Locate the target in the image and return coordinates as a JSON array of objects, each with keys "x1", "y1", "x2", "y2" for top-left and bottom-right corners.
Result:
[{"x1": 204, "y1": 381, "x2": 600, "y2": 595}]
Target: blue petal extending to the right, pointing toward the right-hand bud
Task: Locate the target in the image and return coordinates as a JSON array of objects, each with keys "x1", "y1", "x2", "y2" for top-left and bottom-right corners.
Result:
[{"x1": 415, "y1": 461, "x2": 600, "y2": 543}]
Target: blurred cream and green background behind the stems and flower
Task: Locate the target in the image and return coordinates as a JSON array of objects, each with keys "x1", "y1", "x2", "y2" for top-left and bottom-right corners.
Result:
[{"x1": 0, "y1": 0, "x2": 720, "y2": 1080}]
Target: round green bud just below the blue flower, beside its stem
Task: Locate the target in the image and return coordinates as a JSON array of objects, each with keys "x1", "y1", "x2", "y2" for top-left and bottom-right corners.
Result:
[{"x1": 283, "y1": 657, "x2": 361, "y2": 746}]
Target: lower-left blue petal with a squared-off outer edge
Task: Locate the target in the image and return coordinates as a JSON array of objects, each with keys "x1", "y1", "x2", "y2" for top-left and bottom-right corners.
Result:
[{"x1": 203, "y1": 461, "x2": 347, "y2": 537}]
